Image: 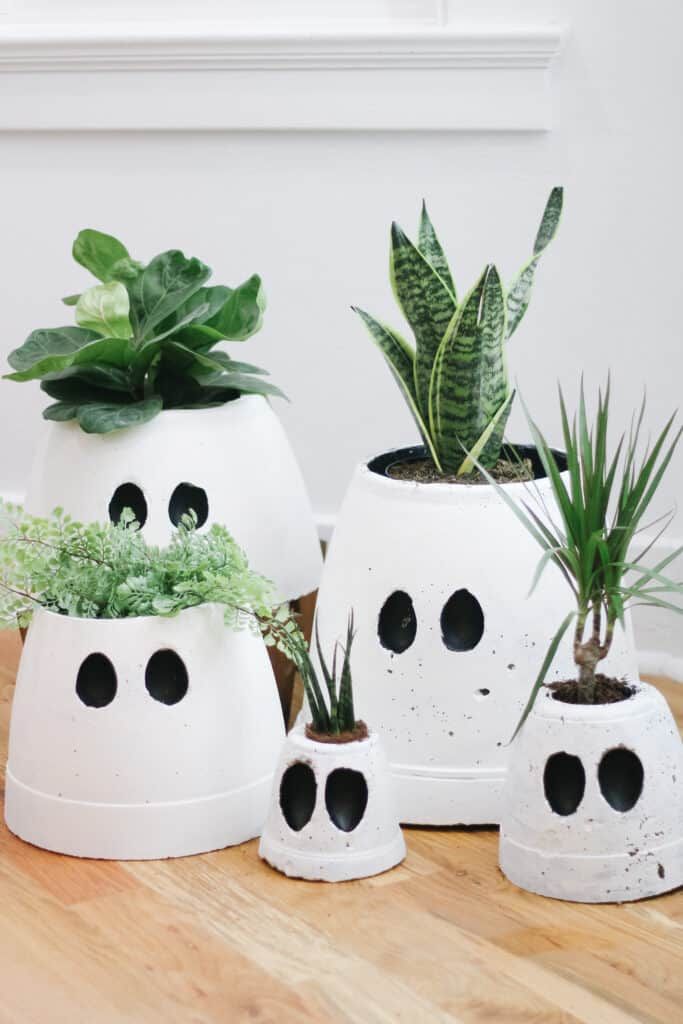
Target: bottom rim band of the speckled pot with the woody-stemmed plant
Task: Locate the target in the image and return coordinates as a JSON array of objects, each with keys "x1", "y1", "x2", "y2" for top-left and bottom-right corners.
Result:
[{"x1": 500, "y1": 834, "x2": 683, "y2": 903}]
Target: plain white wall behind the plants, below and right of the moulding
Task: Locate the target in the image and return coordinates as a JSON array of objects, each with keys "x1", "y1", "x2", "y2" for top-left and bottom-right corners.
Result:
[{"x1": 0, "y1": 0, "x2": 683, "y2": 663}]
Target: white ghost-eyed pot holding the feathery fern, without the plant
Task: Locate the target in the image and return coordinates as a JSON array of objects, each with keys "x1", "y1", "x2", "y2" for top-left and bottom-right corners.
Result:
[{"x1": 5, "y1": 605, "x2": 284, "y2": 859}]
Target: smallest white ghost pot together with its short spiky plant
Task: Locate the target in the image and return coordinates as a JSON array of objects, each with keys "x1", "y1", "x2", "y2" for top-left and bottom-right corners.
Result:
[{"x1": 259, "y1": 615, "x2": 405, "y2": 882}]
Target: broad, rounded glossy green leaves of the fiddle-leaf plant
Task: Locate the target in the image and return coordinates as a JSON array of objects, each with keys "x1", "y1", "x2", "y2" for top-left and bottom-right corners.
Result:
[{"x1": 6, "y1": 229, "x2": 282, "y2": 433}]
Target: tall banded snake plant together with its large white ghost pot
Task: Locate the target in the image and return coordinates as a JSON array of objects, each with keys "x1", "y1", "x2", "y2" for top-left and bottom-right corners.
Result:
[{"x1": 317, "y1": 188, "x2": 637, "y2": 825}]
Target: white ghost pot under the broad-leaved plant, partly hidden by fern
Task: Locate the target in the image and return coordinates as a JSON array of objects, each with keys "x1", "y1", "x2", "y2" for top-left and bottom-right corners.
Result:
[{"x1": 26, "y1": 395, "x2": 322, "y2": 600}]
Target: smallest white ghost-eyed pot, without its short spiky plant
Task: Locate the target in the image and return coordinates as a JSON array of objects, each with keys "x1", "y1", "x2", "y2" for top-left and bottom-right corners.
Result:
[{"x1": 259, "y1": 726, "x2": 405, "y2": 882}]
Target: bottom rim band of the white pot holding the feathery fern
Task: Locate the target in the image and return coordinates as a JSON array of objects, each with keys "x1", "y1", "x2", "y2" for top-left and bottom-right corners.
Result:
[{"x1": 5, "y1": 771, "x2": 272, "y2": 860}]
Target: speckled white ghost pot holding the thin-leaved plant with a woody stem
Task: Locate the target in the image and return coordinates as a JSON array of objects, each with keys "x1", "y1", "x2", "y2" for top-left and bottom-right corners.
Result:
[{"x1": 500, "y1": 683, "x2": 683, "y2": 903}]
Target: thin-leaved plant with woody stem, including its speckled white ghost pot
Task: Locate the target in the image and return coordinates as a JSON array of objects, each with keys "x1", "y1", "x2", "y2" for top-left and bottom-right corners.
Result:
[{"x1": 481, "y1": 383, "x2": 683, "y2": 903}]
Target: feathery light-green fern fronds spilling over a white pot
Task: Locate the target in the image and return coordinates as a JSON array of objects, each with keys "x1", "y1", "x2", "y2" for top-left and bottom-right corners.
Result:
[{"x1": 0, "y1": 503, "x2": 305, "y2": 657}]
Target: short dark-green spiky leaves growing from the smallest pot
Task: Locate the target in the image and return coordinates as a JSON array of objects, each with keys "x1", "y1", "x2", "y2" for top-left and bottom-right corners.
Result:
[{"x1": 294, "y1": 612, "x2": 356, "y2": 736}]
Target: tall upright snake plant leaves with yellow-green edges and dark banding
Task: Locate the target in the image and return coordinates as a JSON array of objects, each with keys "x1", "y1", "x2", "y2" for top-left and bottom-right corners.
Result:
[{"x1": 353, "y1": 187, "x2": 563, "y2": 476}]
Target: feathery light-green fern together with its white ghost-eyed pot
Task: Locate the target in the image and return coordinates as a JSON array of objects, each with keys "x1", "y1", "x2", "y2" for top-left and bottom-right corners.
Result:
[{"x1": 0, "y1": 506, "x2": 305, "y2": 859}]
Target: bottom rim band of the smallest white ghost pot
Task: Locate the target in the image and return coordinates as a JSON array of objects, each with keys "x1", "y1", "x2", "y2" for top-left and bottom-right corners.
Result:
[{"x1": 258, "y1": 834, "x2": 405, "y2": 882}]
